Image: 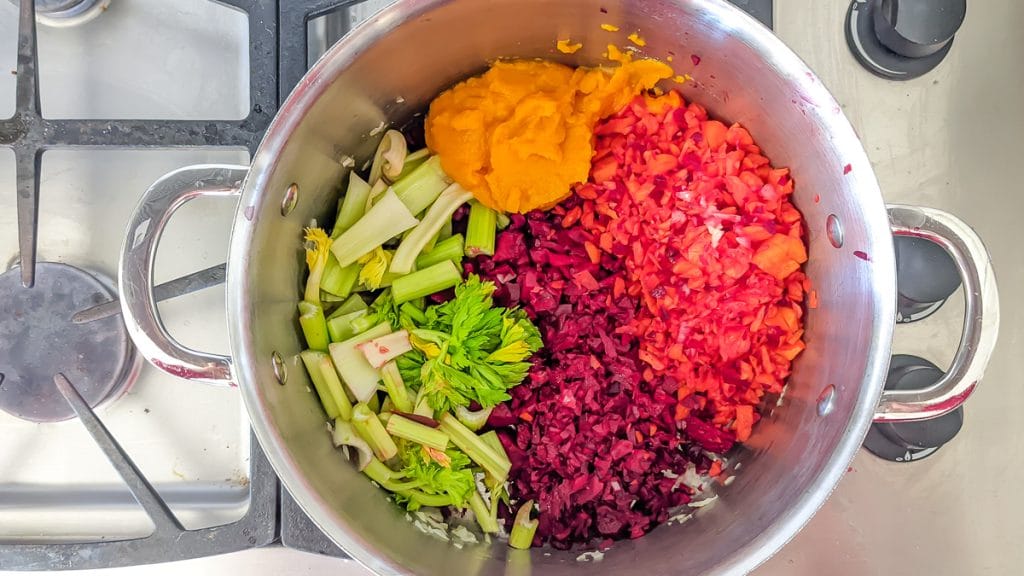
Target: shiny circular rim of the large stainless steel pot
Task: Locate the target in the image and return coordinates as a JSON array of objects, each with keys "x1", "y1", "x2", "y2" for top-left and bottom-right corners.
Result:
[{"x1": 226, "y1": 0, "x2": 896, "y2": 574}]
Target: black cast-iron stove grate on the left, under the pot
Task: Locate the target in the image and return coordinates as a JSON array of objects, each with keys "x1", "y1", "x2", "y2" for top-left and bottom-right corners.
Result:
[{"x1": 0, "y1": 0, "x2": 773, "y2": 570}]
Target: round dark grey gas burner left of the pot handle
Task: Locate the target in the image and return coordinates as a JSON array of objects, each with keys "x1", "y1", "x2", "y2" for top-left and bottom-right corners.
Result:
[{"x1": 0, "y1": 262, "x2": 140, "y2": 422}]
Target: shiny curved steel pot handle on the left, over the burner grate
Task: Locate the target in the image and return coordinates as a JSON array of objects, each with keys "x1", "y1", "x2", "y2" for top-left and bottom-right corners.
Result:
[{"x1": 118, "y1": 164, "x2": 249, "y2": 385}]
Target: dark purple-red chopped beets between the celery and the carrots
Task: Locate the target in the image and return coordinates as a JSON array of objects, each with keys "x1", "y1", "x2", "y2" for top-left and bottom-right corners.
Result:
[{"x1": 466, "y1": 203, "x2": 716, "y2": 548}]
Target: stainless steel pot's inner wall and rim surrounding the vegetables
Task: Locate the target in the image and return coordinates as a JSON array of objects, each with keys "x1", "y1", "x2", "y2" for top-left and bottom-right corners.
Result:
[{"x1": 228, "y1": 0, "x2": 895, "y2": 575}]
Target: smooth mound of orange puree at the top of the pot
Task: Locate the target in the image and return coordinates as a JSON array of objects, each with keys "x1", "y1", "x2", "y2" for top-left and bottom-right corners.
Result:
[{"x1": 426, "y1": 57, "x2": 673, "y2": 212}]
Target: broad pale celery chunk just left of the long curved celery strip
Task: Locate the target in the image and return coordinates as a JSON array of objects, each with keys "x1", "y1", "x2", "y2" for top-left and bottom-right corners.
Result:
[{"x1": 331, "y1": 191, "x2": 419, "y2": 266}]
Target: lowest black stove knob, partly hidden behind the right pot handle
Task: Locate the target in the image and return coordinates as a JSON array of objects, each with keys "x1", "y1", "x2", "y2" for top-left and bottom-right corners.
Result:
[{"x1": 864, "y1": 355, "x2": 964, "y2": 462}]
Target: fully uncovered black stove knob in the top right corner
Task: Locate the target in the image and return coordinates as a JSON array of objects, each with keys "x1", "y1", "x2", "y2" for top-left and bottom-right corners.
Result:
[{"x1": 846, "y1": 0, "x2": 967, "y2": 80}]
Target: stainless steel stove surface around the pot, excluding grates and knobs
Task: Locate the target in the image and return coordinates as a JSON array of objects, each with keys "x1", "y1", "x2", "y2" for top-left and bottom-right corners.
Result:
[{"x1": 0, "y1": 0, "x2": 1024, "y2": 576}]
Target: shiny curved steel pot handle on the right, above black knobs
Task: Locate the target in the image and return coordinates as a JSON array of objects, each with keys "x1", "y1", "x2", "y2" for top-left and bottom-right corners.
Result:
[{"x1": 874, "y1": 204, "x2": 999, "y2": 422}]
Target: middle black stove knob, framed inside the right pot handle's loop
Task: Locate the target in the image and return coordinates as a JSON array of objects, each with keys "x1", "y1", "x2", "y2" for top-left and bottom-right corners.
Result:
[{"x1": 894, "y1": 236, "x2": 961, "y2": 324}]
